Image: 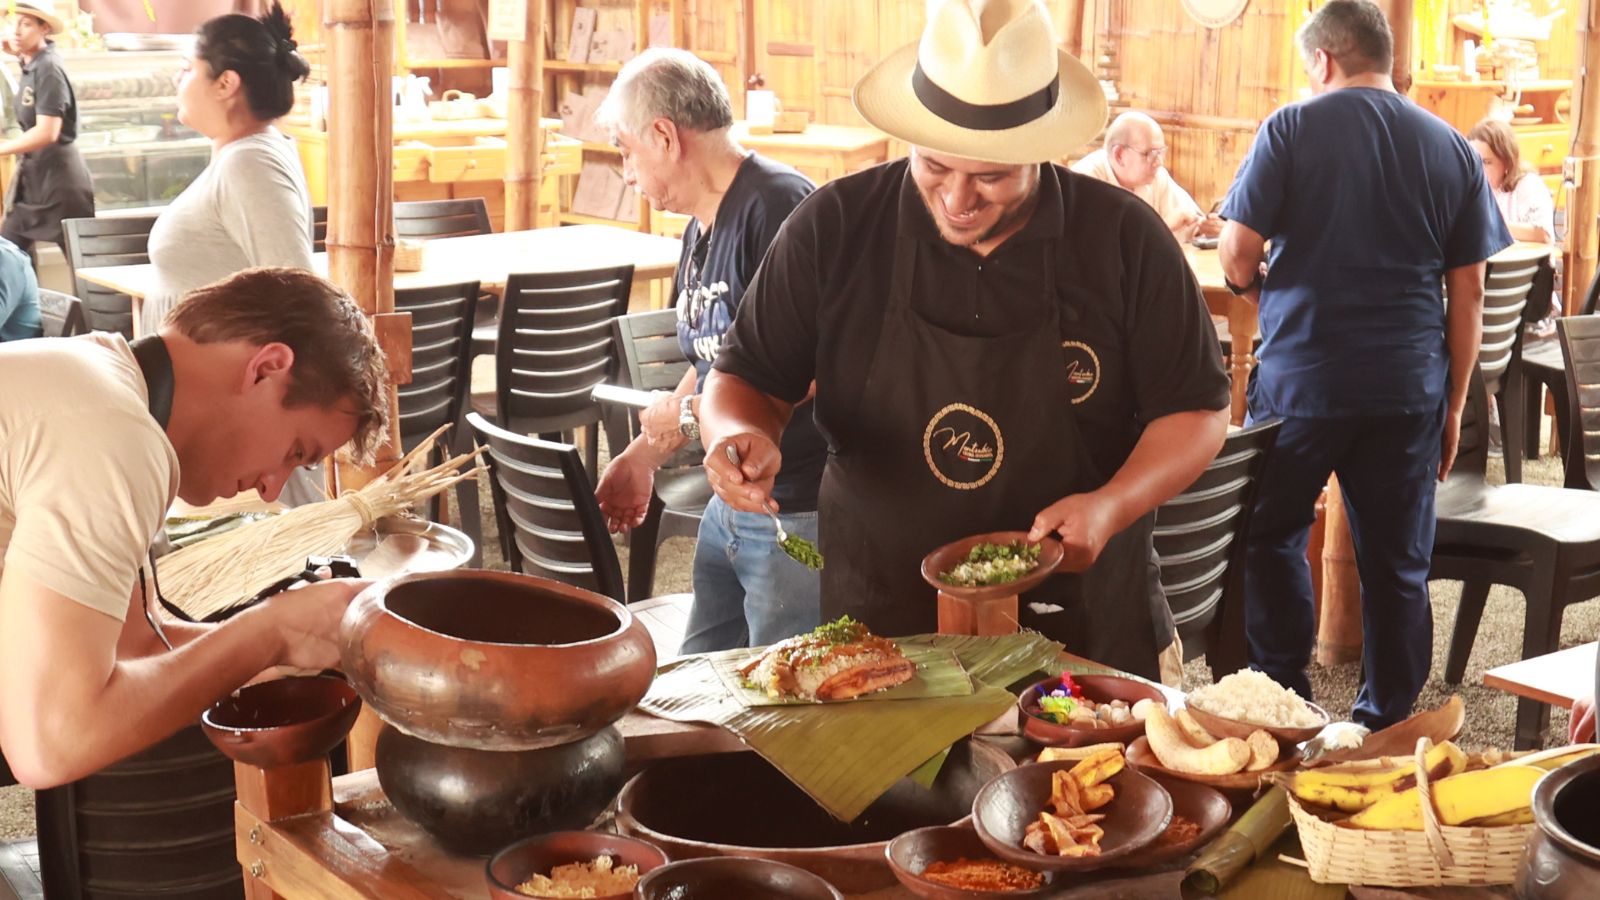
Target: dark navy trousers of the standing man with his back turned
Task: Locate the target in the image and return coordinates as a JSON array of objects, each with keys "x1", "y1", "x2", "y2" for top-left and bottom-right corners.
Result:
[{"x1": 1245, "y1": 404, "x2": 1445, "y2": 730}]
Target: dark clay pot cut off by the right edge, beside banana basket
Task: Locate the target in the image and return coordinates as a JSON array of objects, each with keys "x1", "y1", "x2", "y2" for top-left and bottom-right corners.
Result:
[{"x1": 1517, "y1": 756, "x2": 1600, "y2": 900}]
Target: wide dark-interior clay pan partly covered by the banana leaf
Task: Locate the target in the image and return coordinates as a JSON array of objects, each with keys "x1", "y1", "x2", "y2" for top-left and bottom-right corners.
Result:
[{"x1": 616, "y1": 740, "x2": 1016, "y2": 894}]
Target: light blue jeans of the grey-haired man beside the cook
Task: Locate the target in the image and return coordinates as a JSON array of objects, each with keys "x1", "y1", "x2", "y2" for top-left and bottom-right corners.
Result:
[{"x1": 682, "y1": 496, "x2": 822, "y2": 653}]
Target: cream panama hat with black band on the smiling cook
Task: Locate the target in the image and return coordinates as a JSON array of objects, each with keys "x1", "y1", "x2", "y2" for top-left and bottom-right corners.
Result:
[{"x1": 853, "y1": 0, "x2": 1106, "y2": 165}]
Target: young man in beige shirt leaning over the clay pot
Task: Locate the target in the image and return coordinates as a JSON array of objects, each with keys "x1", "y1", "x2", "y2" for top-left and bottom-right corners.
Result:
[{"x1": 0, "y1": 269, "x2": 387, "y2": 788}]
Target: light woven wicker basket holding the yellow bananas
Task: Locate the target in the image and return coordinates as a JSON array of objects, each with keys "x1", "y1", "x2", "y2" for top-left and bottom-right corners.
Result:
[{"x1": 1290, "y1": 738, "x2": 1534, "y2": 887}]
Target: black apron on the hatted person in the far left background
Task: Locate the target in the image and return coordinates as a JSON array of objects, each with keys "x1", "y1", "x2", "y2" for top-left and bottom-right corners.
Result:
[{"x1": 0, "y1": 50, "x2": 94, "y2": 248}]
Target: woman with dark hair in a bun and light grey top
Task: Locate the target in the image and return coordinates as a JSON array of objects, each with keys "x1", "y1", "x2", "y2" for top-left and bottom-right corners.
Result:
[{"x1": 142, "y1": 2, "x2": 323, "y2": 506}]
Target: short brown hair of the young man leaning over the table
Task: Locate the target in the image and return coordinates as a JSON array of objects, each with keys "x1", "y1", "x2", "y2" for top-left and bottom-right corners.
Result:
[{"x1": 163, "y1": 267, "x2": 389, "y2": 460}]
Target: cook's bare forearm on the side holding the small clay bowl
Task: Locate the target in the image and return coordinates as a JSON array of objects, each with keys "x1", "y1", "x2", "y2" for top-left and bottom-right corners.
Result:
[{"x1": 1096, "y1": 410, "x2": 1227, "y2": 532}]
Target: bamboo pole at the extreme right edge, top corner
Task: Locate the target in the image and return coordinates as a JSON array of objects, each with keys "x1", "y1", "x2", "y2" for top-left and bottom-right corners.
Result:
[{"x1": 1563, "y1": 0, "x2": 1600, "y2": 315}]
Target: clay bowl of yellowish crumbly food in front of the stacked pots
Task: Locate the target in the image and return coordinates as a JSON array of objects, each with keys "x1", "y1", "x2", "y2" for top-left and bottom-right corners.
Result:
[{"x1": 485, "y1": 831, "x2": 667, "y2": 900}]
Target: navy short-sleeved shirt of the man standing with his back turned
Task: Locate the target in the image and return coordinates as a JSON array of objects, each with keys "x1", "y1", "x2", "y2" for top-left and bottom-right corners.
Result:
[{"x1": 1221, "y1": 88, "x2": 1510, "y2": 418}]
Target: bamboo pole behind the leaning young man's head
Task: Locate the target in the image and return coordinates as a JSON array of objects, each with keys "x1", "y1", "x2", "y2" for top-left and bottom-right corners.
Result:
[{"x1": 322, "y1": 0, "x2": 400, "y2": 770}]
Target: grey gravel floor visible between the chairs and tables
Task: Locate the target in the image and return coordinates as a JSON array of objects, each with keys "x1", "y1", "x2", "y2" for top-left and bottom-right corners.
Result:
[{"x1": 0, "y1": 413, "x2": 1574, "y2": 839}]
